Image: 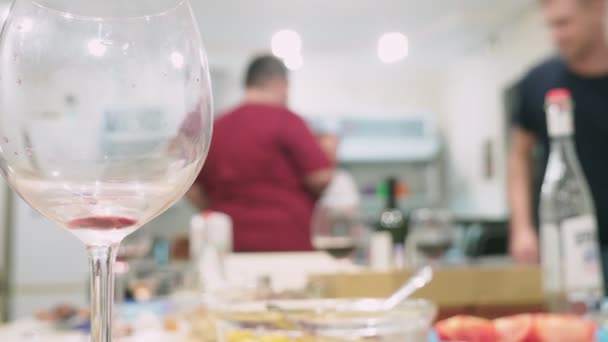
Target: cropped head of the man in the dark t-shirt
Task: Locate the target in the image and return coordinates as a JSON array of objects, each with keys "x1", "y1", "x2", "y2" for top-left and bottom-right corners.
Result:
[{"x1": 541, "y1": 0, "x2": 607, "y2": 62}]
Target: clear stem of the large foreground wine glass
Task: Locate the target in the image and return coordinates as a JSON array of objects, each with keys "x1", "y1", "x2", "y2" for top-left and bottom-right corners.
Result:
[{"x1": 87, "y1": 244, "x2": 118, "y2": 342}]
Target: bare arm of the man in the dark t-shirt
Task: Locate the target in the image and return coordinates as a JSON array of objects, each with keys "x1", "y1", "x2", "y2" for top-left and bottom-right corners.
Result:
[{"x1": 508, "y1": 128, "x2": 539, "y2": 263}]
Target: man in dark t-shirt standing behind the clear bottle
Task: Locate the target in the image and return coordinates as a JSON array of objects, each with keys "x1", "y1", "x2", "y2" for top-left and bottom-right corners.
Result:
[{"x1": 509, "y1": 0, "x2": 608, "y2": 263}]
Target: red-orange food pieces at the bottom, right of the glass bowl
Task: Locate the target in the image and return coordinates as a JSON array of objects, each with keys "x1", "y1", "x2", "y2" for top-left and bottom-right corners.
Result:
[{"x1": 435, "y1": 314, "x2": 596, "y2": 342}]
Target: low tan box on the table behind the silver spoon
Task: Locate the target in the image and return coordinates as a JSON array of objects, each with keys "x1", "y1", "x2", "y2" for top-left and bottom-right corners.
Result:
[{"x1": 311, "y1": 263, "x2": 544, "y2": 318}]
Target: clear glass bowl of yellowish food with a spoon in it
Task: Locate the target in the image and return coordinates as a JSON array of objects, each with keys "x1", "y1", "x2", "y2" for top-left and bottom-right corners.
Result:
[{"x1": 212, "y1": 299, "x2": 437, "y2": 342}]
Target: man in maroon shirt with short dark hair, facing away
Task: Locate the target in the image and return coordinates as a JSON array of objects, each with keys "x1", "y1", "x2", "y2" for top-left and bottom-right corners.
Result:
[{"x1": 188, "y1": 56, "x2": 333, "y2": 252}]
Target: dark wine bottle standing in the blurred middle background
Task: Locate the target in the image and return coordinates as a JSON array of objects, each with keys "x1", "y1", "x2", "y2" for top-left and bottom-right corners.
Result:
[{"x1": 376, "y1": 177, "x2": 408, "y2": 246}]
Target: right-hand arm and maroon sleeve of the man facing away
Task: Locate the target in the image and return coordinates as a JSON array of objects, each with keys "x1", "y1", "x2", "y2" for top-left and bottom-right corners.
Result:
[{"x1": 280, "y1": 113, "x2": 334, "y2": 195}]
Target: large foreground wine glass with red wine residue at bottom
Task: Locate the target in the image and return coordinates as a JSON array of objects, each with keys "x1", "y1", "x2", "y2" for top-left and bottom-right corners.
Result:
[{"x1": 0, "y1": 0, "x2": 212, "y2": 342}]
